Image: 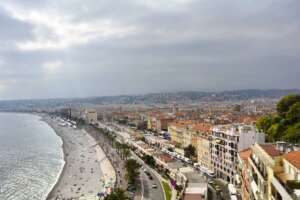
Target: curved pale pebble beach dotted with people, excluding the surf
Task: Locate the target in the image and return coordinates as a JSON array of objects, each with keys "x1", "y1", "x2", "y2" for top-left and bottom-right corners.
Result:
[{"x1": 43, "y1": 116, "x2": 116, "y2": 200}]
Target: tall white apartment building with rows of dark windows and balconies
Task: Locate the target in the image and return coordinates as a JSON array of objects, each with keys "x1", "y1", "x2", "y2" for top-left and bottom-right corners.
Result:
[{"x1": 210, "y1": 124, "x2": 265, "y2": 184}]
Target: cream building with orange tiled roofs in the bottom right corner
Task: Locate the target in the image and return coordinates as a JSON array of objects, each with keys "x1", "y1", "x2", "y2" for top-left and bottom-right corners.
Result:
[{"x1": 249, "y1": 144, "x2": 300, "y2": 200}]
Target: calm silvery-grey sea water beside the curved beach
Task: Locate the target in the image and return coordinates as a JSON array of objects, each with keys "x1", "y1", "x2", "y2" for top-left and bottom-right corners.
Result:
[{"x1": 0, "y1": 113, "x2": 64, "y2": 200}]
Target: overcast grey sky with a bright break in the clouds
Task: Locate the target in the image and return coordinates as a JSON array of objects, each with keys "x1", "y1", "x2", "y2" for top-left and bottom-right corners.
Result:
[{"x1": 0, "y1": 0, "x2": 300, "y2": 99}]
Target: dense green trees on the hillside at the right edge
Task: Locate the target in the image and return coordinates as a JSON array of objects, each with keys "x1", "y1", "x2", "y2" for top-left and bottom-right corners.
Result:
[{"x1": 257, "y1": 94, "x2": 300, "y2": 143}]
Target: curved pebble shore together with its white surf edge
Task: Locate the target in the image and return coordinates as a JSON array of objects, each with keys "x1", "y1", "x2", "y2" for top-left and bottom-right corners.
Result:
[{"x1": 0, "y1": 111, "x2": 117, "y2": 200}]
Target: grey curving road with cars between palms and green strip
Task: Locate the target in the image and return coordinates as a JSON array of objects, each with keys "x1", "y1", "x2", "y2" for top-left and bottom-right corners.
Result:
[{"x1": 132, "y1": 152, "x2": 165, "y2": 200}]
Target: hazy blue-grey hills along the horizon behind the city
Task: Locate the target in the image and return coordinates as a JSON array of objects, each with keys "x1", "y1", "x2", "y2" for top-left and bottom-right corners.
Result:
[{"x1": 0, "y1": 89, "x2": 300, "y2": 110}]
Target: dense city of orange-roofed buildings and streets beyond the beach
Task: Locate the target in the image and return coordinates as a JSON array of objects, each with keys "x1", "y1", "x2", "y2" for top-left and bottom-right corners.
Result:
[{"x1": 2, "y1": 91, "x2": 300, "y2": 200}]
